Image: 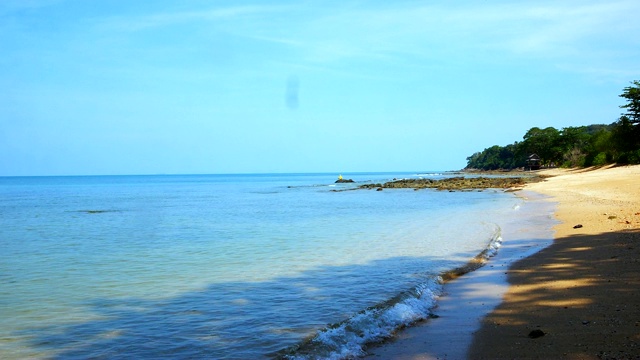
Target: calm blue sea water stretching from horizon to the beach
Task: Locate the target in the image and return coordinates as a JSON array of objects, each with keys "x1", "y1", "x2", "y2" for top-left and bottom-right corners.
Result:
[{"x1": 0, "y1": 173, "x2": 544, "y2": 359}]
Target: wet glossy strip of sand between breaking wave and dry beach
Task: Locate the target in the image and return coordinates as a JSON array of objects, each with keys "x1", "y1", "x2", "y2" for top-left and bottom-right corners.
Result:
[{"x1": 365, "y1": 190, "x2": 555, "y2": 360}]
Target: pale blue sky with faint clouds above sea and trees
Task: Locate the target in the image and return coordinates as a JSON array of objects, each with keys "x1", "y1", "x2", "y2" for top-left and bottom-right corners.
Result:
[{"x1": 0, "y1": 0, "x2": 640, "y2": 176}]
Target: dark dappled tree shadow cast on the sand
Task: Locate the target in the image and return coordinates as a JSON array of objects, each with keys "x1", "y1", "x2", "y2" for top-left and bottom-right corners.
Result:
[{"x1": 468, "y1": 229, "x2": 640, "y2": 359}]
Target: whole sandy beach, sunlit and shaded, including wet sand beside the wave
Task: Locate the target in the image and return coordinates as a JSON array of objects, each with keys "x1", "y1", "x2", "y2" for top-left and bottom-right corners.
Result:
[{"x1": 369, "y1": 166, "x2": 640, "y2": 359}]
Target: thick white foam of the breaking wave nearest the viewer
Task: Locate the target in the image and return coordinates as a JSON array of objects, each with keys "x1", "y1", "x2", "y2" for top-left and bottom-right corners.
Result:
[{"x1": 286, "y1": 276, "x2": 443, "y2": 360}]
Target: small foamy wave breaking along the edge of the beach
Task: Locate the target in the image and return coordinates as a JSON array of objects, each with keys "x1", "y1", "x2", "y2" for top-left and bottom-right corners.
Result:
[{"x1": 276, "y1": 225, "x2": 502, "y2": 360}]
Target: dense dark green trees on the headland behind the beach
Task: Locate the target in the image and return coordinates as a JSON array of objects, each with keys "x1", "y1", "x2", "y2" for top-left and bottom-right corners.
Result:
[{"x1": 467, "y1": 80, "x2": 640, "y2": 170}]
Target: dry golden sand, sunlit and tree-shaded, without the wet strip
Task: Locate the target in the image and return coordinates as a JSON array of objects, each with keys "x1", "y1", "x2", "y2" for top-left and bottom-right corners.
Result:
[{"x1": 468, "y1": 165, "x2": 640, "y2": 359}]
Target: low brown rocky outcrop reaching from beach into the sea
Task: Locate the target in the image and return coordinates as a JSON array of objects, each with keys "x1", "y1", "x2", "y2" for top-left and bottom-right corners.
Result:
[{"x1": 360, "y1": 176, "x2": 541, "y2": 191}]
